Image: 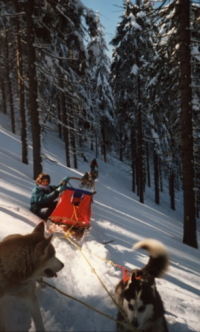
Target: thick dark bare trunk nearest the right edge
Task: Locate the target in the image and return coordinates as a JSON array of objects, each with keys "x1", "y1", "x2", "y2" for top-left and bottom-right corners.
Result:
[{"x1": 179, "y1": 0, "x2": 198, "y2": 248}]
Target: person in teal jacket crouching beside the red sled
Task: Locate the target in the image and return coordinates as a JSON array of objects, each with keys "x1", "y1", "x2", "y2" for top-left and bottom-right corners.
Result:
[{"x1": 30, "y1": 173, "x2": 70, "y2": 220}]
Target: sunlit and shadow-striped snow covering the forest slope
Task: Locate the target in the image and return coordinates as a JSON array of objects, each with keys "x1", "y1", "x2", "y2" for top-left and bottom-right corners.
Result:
[{"x1": 0, "y1": 113, "x2": 200, "y2": 332}]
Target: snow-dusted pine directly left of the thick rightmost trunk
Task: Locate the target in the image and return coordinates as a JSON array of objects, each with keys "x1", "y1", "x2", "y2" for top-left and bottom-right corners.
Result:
[{"x1": 147, "y1": 3, "x2": 181, "y2": 209}]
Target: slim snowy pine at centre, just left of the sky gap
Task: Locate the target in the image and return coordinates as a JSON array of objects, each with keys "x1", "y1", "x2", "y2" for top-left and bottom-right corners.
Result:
[{"x1": 88, "y1": 14, "x2": 114, "y2": 162}]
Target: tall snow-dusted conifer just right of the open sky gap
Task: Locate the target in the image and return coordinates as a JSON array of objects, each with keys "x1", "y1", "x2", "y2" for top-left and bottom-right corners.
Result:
[{"x1": 111, "y1": 0, "x2": 157, "y2": 203}]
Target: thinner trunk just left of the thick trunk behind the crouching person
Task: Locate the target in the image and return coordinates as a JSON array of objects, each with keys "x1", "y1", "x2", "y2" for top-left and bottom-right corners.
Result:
[{"x1": 14, "y1": 0, "x2": 28, "y2": 164}]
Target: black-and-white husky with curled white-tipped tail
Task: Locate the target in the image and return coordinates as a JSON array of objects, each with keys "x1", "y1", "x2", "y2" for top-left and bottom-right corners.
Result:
[{"x1": 115, "y1": 239, "x2": 169, "y2": 332}]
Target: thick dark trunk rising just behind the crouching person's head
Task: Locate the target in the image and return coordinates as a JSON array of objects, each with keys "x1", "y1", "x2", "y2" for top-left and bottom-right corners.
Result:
[{"x1": 26, "y1": 0, "x2": 42, "y2": 179}]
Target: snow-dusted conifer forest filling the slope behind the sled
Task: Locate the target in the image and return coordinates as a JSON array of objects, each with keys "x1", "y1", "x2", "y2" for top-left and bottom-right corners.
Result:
[{"x1": 0, "y1": 0, "x2": 200, "y2": 248}]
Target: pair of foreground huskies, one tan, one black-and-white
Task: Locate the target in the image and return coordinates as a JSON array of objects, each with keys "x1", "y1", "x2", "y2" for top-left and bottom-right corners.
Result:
[{"x1": 0, "y1": 222, "x2": 169, "y2": 332}]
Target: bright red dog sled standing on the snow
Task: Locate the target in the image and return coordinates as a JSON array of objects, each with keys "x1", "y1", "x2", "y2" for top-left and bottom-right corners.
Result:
[{"x1": 47, "y1": 177, "x2": 95, "y2": 240}]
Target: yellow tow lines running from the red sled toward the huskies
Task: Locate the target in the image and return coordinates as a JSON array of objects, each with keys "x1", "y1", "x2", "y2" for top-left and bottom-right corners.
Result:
[{"x1": 53, "y1": 233, "x2": 139, "y2": 332}]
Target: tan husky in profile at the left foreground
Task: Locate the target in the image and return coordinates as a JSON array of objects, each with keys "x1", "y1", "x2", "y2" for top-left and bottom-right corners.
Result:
[{"x1": 0, "y1": 222, "x2": 64, "y2": 331}]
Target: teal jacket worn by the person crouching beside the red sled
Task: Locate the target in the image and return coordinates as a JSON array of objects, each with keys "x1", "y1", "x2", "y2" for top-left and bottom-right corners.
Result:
[{"x1": 30, "y1": 185, "x2": 59, "y2": 214}]
